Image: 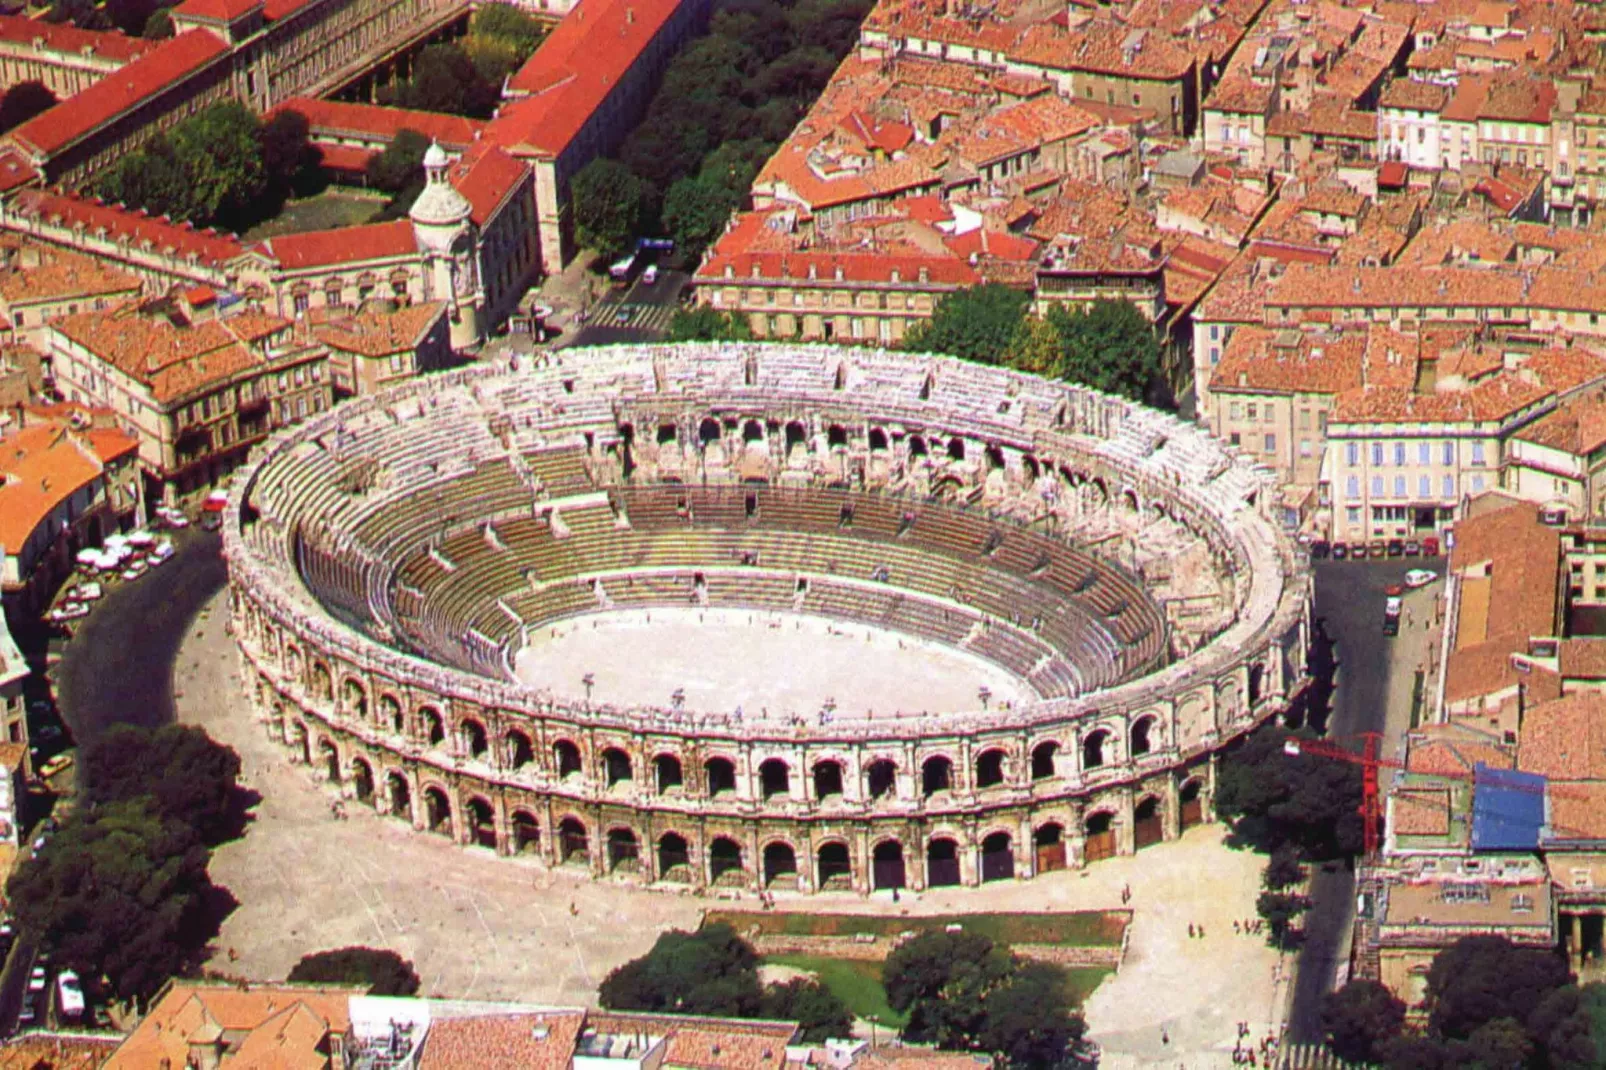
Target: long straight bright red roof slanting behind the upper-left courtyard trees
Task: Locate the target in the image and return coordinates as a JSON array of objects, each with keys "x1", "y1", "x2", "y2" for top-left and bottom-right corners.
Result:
[{"x1": 11, "y1": 29, "x2": 230, "y2": 157}]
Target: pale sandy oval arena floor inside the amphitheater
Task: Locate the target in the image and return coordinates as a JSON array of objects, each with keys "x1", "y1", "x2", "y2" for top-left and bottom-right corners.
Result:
[{"x1": 514, "y1": 607, "x2": 1033, "y2": 720}]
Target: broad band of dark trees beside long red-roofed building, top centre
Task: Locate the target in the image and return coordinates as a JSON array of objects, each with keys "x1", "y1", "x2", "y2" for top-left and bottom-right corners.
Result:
[{"x1": 572, "y1": 0, "x2": 870, "y2": 259}]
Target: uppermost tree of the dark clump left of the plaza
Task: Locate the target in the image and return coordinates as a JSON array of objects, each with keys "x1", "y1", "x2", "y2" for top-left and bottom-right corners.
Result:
[{"x1": 82, "y1": 725, "x2": 239, "y2": 843}]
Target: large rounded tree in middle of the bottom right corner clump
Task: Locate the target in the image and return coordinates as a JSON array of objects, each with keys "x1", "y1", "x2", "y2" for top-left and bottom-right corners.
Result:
[{"x1": 1426, "y1": 937, "x2": 1572, "y2": 1039}]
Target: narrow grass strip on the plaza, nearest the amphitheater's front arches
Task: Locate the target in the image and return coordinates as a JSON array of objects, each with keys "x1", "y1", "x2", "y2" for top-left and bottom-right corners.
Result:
[{"x1": 703, "y1": 911, "x2": 1126, "y2": 948}]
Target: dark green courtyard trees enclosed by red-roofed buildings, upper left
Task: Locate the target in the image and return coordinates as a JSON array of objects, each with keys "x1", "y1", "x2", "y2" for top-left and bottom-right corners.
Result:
[{"x1": 95, "y1": 101, "x2": 321, "y2": 231}]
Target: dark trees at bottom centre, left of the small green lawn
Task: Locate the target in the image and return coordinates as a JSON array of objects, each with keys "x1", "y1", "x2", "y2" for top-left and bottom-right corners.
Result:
[{"x1": 597, "y1": 924, "x2": 853, "y2": 1043}]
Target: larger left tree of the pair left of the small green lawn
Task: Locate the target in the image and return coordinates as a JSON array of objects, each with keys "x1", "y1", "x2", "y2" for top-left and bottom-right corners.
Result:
[{"x1": 597, "y1": 925, "x2": 763, "y2": 1017}]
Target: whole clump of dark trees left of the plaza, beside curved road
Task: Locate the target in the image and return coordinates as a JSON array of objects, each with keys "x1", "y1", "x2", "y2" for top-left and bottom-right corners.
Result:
[{"x1": 6, "y1": 725, "x2": 243, "y2": 1001}]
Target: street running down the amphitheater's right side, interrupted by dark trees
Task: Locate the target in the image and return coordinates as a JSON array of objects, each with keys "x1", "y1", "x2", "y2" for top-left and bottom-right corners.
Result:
[{"x1": 1288, "y1": 557, "x2": 1445, "y2": 1044}]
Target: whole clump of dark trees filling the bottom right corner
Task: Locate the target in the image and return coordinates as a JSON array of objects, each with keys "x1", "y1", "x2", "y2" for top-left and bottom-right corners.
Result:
[{"x1": 1322, "y1": 937, "x2": 1606, "y2": 1070}]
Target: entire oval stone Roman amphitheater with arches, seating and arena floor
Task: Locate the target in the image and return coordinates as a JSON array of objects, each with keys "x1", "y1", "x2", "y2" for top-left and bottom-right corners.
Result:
[{"x1": 225, "y1": 345, "x2": 1310, "y2": 892}]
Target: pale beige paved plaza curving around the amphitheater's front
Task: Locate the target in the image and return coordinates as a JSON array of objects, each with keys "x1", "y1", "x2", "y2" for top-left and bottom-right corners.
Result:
[{"x1": 184, "y1": 594, "x2": 1283, "y2": 1067}]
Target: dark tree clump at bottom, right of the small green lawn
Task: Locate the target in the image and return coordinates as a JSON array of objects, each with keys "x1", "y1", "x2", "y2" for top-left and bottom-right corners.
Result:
[{"x1": 882, "y1": 930, "x2": 1084, "y2": 1067}]
